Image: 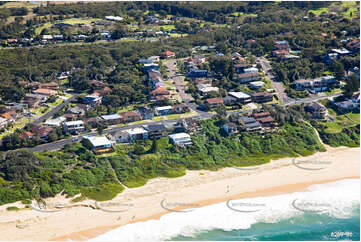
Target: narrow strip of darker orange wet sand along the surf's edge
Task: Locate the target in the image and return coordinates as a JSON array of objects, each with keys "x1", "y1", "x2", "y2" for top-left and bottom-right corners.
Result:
[{"x1": 51, "y1": 176, "x2": 360, "y2": 241}]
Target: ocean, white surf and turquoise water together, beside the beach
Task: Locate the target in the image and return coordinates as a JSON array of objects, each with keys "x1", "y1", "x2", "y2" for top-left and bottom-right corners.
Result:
[{"x1": 92, "y1": 179, "x2": 360, "y2": 241}]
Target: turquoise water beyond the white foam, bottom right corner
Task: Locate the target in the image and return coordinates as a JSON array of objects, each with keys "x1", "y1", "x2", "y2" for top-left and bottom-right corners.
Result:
[{"x1": 170, "y1": 206, "x2": 360, "y2": 241}]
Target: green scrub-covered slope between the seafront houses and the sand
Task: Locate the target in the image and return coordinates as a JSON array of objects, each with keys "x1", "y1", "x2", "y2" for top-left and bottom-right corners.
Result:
[{"x1": 0, "y1": 116, "x2": 324, "y2": 204}]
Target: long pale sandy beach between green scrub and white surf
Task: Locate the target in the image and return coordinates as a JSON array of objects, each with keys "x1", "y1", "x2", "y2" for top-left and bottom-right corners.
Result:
[{"x1": 0, "y1": 147, "x2": 360, "y2": 240}]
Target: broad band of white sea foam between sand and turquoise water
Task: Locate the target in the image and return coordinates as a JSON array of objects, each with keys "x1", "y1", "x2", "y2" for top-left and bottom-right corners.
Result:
[{"x1": 91, "y1": 179, "x2": 360, "y2": 241}]
